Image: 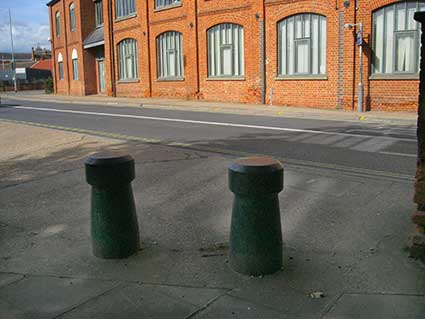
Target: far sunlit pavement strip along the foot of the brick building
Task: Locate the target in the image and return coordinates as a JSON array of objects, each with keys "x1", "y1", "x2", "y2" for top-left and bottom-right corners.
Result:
[{"x1": 2, "y1": 91, "x2": 417, "y2": 125}]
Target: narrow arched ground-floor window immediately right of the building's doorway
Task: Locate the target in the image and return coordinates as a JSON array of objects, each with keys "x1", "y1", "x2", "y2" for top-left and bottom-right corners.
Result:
[{"x1": 118, "y1": 39, "x2": 138, "y2": 80}]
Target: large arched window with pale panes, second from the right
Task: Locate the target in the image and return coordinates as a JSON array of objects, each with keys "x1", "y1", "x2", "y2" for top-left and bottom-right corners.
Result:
[{"x1": 277, "y1": 13, "x2": 326, "y2": 76}]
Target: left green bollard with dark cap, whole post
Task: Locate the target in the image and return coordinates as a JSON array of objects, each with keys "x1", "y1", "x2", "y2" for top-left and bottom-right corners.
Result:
[{"x1": 85, "y1": 154, "x2": 140, "y2": 259}]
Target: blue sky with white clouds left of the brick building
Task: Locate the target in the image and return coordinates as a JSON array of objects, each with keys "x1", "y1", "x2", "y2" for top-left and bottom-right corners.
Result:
[{"x1": 0, "y1": 0, "x2": 50, "y2": 52}]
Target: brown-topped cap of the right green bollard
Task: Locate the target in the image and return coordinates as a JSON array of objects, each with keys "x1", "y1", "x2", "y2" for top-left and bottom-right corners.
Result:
[{"x1": 229, "y1": 156, "x2": 283, "y2": 195}]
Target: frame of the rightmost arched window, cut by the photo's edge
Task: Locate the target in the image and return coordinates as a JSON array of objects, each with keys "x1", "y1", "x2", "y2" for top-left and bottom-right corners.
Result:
[{"x1": 370, "y1": 1, "x2": 425, "y2": 78}]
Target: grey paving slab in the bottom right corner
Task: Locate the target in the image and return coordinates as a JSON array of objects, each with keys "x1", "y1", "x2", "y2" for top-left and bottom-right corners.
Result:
[{"x1": 324, "y1": 294, "x2": 425, "y2": 319}]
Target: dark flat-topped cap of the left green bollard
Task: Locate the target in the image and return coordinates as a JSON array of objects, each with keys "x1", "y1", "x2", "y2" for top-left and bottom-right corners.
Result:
[{"x1": 84, "y1": 153, "x2": 135, "y2": 187}]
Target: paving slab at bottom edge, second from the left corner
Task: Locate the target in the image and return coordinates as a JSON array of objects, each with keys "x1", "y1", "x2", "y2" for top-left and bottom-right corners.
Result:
[{"x1": 60, "y1": 284, "x2": 226, "y2": 319}]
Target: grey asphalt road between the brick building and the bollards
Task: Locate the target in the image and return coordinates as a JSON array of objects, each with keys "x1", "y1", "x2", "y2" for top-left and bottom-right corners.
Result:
[{"x1": 0, "y1": 100, "x2": 417, "y2": 180}]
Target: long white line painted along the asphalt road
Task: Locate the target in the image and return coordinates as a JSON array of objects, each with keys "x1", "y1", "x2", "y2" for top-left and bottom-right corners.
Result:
[{"x1": 11, "y1": 106, "x2": 415, "y2": 142}]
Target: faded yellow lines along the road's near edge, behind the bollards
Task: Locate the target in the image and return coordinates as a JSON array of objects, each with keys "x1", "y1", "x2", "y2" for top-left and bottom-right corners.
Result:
[{"x1": 0, "y1": 118, "x2": 414, "y2": 181}]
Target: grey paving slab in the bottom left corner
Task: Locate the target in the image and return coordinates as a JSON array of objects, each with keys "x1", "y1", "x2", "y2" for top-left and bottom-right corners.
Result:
[{"x1": 0, "y1": 276, "x2": 117, "y2": 319}]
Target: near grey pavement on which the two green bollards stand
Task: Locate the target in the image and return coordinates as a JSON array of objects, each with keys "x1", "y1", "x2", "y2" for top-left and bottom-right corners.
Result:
[{"x1": 0, "y1": 121, "x2": 425, "y2": 319}]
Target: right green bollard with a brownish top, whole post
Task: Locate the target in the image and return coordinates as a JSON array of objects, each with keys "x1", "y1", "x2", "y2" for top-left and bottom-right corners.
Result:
[{"x1": 229, "y1": 157, "x2": 283, "y2": 276}]
